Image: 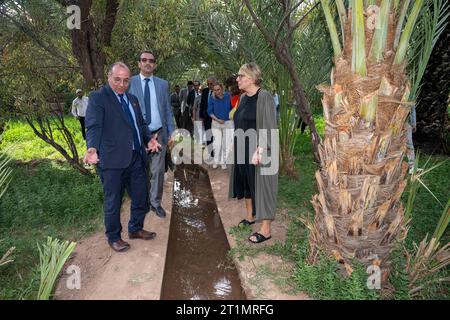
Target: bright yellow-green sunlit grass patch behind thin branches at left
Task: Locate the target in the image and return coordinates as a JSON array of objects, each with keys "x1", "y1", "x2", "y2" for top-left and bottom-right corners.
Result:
[{"x1": 0, "y1": 116, "x2": 86, "y2": 161}]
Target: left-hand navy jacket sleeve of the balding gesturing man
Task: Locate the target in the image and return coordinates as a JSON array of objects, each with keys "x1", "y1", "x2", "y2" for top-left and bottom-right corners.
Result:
[{"x1": 85, "y1": 92, "x2": 105, "y2": 151}]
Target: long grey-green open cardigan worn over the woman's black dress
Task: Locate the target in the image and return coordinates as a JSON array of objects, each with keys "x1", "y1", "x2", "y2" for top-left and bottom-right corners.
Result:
[{"x1": 228, "y1": 89, "x2": 279, "y2": 221}]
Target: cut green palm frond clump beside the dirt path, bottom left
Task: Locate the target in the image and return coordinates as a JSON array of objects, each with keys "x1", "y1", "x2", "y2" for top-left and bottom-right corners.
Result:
[{"x1": 37, "y1": 237, "x2": 76, "y2": 300}]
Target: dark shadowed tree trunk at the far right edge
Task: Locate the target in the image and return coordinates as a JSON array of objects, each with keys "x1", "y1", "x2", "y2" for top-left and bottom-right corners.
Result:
[{"x1": 414, "y1": 17, "x2": 450, "y2": 155}]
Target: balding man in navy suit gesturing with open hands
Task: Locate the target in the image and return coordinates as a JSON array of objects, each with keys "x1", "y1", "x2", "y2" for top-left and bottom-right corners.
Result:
[{"x1": 84, "y1": 62, "x2": 159, "y2": 252}]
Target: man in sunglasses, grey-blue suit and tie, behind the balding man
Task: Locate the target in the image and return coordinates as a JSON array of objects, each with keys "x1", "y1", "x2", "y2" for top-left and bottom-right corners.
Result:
[{"x1": 129, "y1": 51, "x2": 175, "y2": 218}]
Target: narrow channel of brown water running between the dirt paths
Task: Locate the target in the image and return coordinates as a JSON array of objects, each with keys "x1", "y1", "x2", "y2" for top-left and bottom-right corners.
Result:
[{"x1": 161, "y1": 165, "x2": 246, "y2": 300}]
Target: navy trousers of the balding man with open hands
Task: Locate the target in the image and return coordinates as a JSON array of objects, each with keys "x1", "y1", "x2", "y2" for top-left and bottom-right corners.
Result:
[{"x1": 99, "y1": 151, "x2": 148, "y2": 242}]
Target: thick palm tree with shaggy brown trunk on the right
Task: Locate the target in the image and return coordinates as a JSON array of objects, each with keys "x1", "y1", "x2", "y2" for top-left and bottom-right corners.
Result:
[{"x1": 310, "y1": 0, "x2": 446, "y2": 280}]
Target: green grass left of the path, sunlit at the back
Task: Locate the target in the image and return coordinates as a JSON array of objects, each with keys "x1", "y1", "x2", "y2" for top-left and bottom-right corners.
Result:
[{"x1": 0, "y1": 116, "x2": 103, "y2": 299}]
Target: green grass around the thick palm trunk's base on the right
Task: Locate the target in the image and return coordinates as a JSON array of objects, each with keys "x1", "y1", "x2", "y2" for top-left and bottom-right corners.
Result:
[{"x1": 231, "y1": 118, "x2": 450, "y2": 299}]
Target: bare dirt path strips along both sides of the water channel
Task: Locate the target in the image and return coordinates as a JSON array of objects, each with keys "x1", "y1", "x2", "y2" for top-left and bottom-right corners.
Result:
[{"x1": 55, "y1": 167, "x2": 308, "y2": 300}]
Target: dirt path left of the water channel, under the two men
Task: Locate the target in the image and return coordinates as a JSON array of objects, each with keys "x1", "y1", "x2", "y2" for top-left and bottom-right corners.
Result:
[{"x1": 56, "y1": 172, "x2": 173, "y2": 300}]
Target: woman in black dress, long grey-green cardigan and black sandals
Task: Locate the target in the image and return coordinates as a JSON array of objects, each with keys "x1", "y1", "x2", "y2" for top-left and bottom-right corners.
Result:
[{"x1": 229, "y1": 63, "x2": 278, "y2": 243}]
